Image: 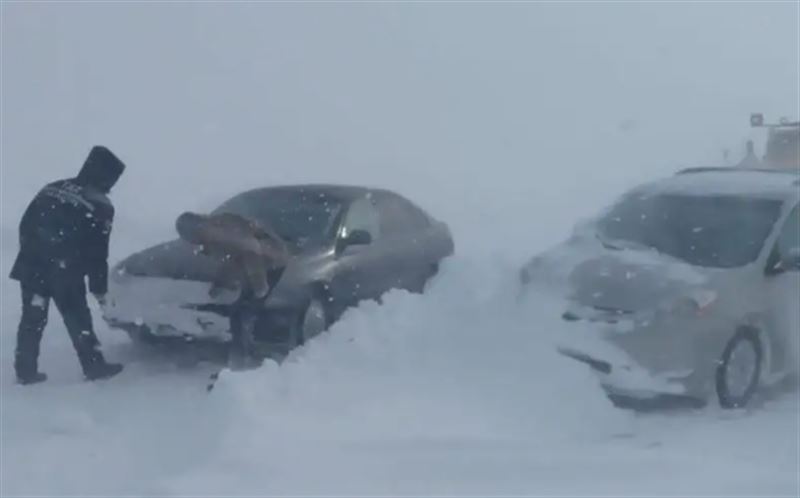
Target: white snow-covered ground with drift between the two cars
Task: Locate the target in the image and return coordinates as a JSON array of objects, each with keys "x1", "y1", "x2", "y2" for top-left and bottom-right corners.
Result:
[{"x1": 2, "y1": 258, "x2": 800, "y2": 496}]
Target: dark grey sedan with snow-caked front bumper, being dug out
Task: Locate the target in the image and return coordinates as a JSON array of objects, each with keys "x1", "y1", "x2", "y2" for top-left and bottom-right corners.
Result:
[{"x1": 104, "y1": 185, "x2": 454, "y2": 354}]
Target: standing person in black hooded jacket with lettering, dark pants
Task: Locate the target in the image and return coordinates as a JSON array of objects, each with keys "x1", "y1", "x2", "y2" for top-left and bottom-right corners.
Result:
[{"x1": 11, "y1": 146, "x2": 125, "y2": 384}]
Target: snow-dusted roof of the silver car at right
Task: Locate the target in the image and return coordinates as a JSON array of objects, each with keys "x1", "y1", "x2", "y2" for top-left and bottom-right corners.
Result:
[{"x1": 640, "y1": 168, "x2": 800, "y2": 199}]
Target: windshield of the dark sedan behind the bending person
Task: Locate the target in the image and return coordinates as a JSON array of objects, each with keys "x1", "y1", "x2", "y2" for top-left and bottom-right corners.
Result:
[{"x1": 214, "y1": 190, "x2": 342, "y2": 249}]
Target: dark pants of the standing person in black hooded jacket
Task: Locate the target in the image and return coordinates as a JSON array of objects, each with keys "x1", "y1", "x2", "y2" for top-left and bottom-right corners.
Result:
[{"x1": 14, "y1": 284, "x2": 104, "y2": 378}]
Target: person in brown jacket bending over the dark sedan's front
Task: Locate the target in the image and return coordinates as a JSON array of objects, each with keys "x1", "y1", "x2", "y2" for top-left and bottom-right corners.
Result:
[{"x1": 175, "y1": 212, "x2": 289, "y2": 369}]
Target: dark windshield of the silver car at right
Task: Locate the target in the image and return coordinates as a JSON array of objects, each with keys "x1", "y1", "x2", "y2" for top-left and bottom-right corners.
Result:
[{"x1": 597, "y1": 193, "x2": 781, "y2": 268}]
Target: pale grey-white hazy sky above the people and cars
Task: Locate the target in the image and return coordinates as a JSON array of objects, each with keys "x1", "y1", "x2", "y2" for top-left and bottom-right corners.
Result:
[{"x1": 2, "y1": 2, "x2": 800, "y2": 258}]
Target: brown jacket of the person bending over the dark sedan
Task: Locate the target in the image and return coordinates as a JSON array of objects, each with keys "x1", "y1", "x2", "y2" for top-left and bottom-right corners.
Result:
[{"x1": 175, "y1": 212, "x2": 290, "y2": 298}]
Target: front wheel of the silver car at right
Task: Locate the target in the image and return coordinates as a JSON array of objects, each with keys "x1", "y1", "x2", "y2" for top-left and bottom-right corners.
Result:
[{"x1": 716, "y1": 329, "x2": 763, "y2": 409}]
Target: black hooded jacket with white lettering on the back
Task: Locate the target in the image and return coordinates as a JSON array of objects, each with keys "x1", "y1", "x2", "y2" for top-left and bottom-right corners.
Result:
[{"x1": 11, "y1": 146, "x2": 125, "y2": 295}]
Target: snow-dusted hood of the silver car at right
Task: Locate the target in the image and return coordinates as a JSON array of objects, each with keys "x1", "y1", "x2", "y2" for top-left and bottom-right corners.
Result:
[{"x1": 569, "y1": 250, "x2": 708, "y2": 313}]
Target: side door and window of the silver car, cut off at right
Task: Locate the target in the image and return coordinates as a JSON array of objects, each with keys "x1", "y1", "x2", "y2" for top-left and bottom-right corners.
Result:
[{"x1": 766, "y1": 200, "x2": 800, "y2": 372}]
